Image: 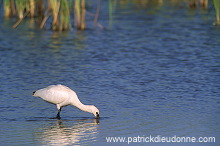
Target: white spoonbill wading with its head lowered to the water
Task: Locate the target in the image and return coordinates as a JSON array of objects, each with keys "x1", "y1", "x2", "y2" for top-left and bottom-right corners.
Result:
[{"x1": 33, "y1": 85, "x2": 99, "y2": 119}]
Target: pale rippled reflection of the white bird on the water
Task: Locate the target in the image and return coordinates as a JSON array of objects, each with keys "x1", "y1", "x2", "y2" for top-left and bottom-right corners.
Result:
[{"x1": 35, "y1": 119, "x2": 99, "y2": 146}]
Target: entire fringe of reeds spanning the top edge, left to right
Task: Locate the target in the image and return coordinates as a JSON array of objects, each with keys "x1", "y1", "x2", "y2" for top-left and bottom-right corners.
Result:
[{"x1": 3, "y1": 0, "x2": 220, "y2": 31}]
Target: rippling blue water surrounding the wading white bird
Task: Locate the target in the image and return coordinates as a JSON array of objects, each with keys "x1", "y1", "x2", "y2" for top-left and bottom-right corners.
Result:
[{"x1": 0, "y1": 1, "x2": 220, "y2": 146}]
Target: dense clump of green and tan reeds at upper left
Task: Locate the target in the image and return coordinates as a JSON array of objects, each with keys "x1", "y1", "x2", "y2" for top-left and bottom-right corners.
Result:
[{"x1": 3, "y1": 0, "x2": 104, "y2": 31}]
